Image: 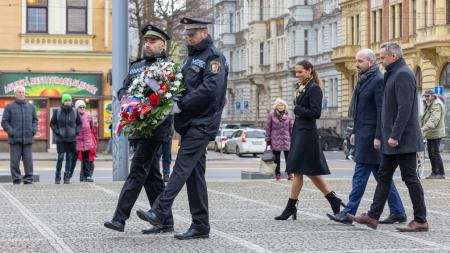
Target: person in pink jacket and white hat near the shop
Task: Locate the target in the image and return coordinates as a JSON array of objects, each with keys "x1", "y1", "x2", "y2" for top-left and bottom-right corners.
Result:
[{"x1": 75, "y1": 100, "x2": 94, "y2": 182}]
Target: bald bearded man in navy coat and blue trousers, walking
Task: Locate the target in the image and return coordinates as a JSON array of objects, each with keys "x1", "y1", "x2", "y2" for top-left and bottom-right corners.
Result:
[{"x1": 327, "y1": 49, "x2": 406, "y2": 224}]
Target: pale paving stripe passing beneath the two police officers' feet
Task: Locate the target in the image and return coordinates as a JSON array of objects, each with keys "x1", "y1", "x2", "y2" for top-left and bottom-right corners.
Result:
[{"x1": 89, "y1": 184, "x2": 272, "y2": 253}]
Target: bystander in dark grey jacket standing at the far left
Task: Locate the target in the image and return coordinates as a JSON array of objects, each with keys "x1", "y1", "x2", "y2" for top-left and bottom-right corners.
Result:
[{"x1": 2, "y1": 86, "x2": 38, "y2": 184}]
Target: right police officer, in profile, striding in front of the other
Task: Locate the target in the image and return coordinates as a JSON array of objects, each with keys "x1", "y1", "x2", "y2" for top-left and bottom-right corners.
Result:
[{"x1": 137, "y1": 18, "x2": 228, "y2": 240}]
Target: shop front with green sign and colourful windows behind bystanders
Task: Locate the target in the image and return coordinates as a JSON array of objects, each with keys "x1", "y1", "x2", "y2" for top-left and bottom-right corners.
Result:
[{"x1": 0, "y1": 72, "x2": 112, "y2": 152}]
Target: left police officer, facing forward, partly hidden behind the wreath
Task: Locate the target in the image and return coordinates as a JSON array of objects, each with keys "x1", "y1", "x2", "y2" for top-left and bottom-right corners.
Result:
[{"x1": 104, "y1": 25, "x2": 173, "y2": 234}]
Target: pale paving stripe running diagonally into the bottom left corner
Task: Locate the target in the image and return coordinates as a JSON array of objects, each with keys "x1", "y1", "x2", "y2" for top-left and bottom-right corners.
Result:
[{"x1": 0, "y1": 184, "x2": 73, "y2": 253}]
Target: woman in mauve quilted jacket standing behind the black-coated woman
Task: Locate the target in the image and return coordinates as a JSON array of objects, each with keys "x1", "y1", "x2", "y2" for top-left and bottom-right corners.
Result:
[{"x1": 266, "y1": 98, "x2": 294, "y2": 181}]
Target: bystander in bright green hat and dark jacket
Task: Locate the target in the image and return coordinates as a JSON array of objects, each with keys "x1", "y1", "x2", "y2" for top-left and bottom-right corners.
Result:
[{"x1": 50, "y1": 94, "x2": 81, "y2": 184}]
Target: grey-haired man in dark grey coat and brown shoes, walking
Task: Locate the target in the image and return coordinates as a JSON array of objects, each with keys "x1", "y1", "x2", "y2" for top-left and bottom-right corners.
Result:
[{"x1": 347, "y1": 42, "x2": 428, "y2": 232}]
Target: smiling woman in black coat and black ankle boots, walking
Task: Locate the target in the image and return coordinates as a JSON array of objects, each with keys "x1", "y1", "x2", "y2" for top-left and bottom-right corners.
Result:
[{"x1": 275, "y1": 60, "x2": 344, "y2": 220}]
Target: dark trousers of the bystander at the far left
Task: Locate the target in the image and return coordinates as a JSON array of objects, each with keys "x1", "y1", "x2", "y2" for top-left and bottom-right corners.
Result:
[{"x1": 9, "y1": 143, "x2": 33, "y2": 183}]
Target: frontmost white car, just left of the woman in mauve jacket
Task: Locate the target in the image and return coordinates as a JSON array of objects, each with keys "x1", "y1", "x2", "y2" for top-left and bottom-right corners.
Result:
[{"x1": 224, "y1": 128, "x2": 266, "y2": 157}]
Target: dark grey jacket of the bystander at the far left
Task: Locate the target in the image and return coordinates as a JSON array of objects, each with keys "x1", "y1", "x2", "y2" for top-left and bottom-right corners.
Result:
[{"x1": 2, "y1": 100, "x2": 38, "y2": 144}]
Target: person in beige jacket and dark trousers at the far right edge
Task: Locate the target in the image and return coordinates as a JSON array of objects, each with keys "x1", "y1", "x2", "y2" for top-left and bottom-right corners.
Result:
[{"x1": 422, "y1": 90, "x2": 445, "y2": 179}]
